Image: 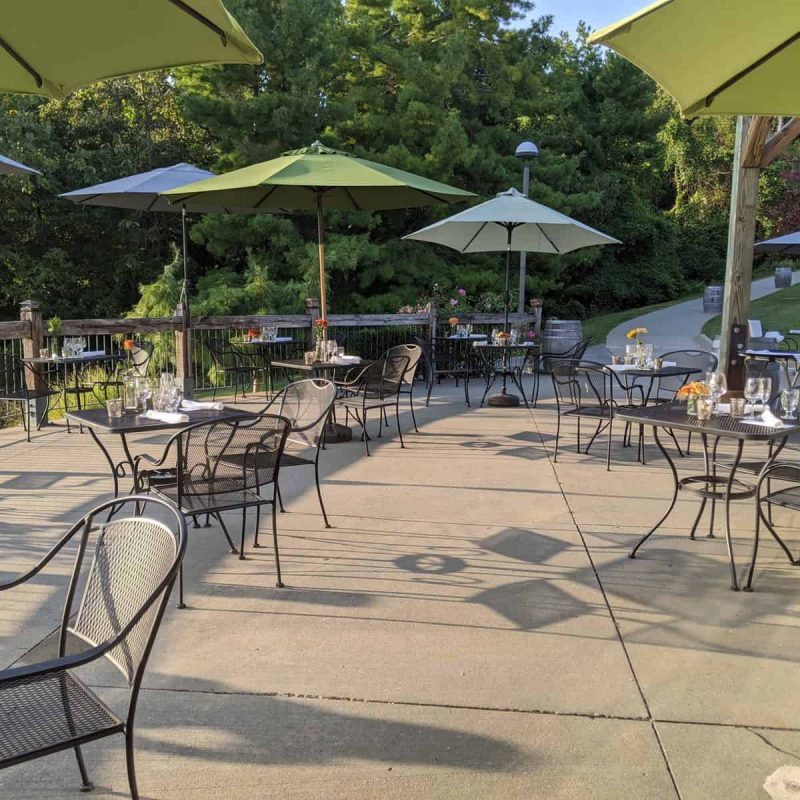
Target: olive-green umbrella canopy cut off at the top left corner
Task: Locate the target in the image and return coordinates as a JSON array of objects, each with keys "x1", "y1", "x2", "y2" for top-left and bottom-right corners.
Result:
[{"x1": 0, "y1": 0, "x2": 263, "y2": 99}]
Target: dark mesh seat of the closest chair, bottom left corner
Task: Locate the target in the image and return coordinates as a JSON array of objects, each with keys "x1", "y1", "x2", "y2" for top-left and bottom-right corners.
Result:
[{"x1": 0, "y1": 671, "x2": 125, "y2": 766}]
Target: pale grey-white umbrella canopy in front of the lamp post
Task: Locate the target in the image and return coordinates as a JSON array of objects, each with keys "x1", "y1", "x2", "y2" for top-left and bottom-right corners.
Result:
[{"x1": 403, "y1": 189, "x2": 620, "y2": 253}]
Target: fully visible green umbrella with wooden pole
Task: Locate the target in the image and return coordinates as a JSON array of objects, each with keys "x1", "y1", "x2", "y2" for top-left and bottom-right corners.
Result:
[{"x1": 163, "y1": 142, "x2": 475, "y2": 319}]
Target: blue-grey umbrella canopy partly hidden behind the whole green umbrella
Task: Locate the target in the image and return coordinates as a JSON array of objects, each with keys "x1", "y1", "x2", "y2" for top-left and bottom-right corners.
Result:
[{"x1": 59, "y1": 163, "x2": 216, "y2": 212}]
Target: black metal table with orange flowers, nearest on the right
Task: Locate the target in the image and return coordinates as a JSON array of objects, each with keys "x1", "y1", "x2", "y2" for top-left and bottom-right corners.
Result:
[{"x1": 617, "y1": 403, "x2": 800, "y2": 591}]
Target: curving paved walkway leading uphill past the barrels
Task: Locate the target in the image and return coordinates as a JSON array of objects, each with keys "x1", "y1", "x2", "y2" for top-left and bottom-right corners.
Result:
[{"x1": 606, "y1": 272, "x2": 800, "y2": 353}]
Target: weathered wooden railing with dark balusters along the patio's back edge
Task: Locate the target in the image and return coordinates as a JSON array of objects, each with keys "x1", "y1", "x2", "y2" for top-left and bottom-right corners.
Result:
[{"x1": 0, "y1": 300, "x2": 541, "y2": 419}]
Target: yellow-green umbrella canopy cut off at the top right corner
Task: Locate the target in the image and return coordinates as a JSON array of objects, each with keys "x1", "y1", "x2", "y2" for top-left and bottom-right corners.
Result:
[{"x1": 589, "y1": 0, "x2": 800, "y2": 117}]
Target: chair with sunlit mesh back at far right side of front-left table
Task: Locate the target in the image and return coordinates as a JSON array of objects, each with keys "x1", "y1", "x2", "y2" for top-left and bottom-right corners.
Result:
[{"x1": 260, "y1": 378, "x2": 336, "y2": 528}]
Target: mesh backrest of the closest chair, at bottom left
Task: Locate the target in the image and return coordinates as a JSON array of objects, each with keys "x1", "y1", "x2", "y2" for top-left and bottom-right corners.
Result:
[{"x1": 65, "y1": 497, "x2": 186, "y2": 685}]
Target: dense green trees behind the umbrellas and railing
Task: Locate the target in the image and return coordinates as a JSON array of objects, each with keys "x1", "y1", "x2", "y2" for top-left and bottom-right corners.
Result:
[{"x1": 0, "y1": 0, "x2": 800, "y2": 324}]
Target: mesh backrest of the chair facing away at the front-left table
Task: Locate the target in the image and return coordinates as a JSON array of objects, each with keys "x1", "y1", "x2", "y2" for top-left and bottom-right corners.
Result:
[{"x1": 176, "y1": 414, "x2": 291, "y2": 505}]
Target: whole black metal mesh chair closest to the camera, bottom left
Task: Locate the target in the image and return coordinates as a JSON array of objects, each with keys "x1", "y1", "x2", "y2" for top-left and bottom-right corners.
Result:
[{"x1": 0, "y1": 496, "x2": 186, "y2": 800}]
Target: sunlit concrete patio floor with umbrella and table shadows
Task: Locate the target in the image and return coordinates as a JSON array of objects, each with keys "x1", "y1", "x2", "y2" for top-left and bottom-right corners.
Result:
[{"x1": 0, "y1": 376, "x2": 800, "y2": 800}]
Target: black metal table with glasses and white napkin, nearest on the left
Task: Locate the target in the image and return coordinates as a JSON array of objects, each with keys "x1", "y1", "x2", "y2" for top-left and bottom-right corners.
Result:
[{"x1": 67, "y1": 408, "x2": 250, "y2": 497}]
